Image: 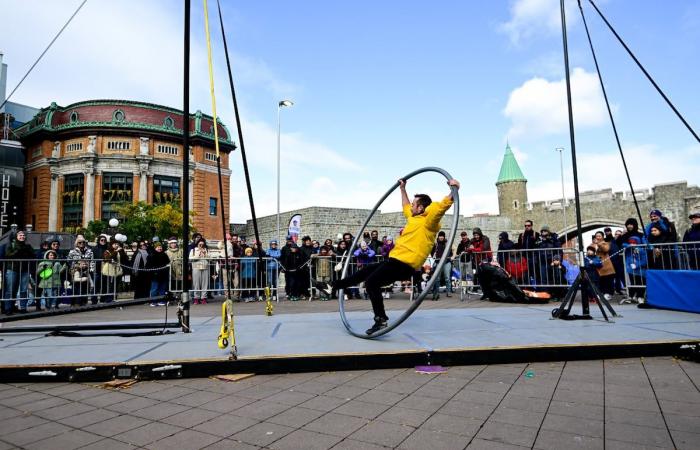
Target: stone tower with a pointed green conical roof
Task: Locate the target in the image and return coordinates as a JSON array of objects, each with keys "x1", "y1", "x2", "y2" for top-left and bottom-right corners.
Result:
[{"x1": 496, "y1": 144, "x2": 527, "y2": 227}]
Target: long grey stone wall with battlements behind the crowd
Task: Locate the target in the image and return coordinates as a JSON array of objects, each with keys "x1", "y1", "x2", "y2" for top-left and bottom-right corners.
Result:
[{"x1": 232, "y1": 181, "x2": 700, "y2": 247}]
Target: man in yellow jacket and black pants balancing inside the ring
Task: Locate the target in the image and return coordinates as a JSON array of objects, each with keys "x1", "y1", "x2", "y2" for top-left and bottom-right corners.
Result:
[{"x1": 326, "y1": 179, "x2": 459, "y2": 334}]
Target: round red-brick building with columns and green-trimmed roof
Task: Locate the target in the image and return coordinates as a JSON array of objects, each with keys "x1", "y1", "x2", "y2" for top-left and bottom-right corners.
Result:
[{"x1": 17, "y1": 100, "x2": 235, "y2": 236}]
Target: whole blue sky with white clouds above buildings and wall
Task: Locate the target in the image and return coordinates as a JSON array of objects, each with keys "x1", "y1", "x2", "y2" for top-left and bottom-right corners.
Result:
[{"x1": 0, "y1": 0, "x2": 700, "y2": 222}]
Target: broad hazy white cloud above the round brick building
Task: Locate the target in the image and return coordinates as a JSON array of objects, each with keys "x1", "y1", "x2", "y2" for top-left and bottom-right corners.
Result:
[{"x1": 0, "y1": 0, "x2": 298, "y2": 116}]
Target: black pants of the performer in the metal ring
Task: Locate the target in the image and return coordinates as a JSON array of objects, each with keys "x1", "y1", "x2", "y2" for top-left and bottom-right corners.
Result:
[{"x1": 334, "y1": 258, "x2": 414, "y2": 320}]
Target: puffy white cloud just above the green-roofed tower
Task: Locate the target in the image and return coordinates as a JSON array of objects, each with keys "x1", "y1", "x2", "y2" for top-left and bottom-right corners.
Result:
[{"x1": 503, "y1": 67, "x2": 607, "y2": 138}]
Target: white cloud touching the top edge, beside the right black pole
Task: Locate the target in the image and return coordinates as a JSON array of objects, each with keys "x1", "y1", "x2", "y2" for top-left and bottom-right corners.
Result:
[{"x1": 499, "y1": 0, "x2": 568, "y2": 45}]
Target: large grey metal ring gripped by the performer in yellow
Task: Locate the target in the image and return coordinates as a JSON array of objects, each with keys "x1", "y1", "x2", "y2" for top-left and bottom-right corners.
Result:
[{"x1": 338, "y1": 167, "x2": 459, "y2": 339}]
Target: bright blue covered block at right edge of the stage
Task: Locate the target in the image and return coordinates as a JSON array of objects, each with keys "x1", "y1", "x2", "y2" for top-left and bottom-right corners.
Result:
[{"x1": 647, "y1": 270, "x2": 700, "y2": 313}]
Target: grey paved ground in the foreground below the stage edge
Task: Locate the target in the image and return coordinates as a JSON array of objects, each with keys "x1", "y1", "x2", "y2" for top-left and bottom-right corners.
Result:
[{"x1": 0, "y1": 357, "x2": 700, "y2": 450}]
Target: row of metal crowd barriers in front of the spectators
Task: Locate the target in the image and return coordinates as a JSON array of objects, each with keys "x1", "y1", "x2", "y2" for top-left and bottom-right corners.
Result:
[{"x1": 0, "y1": 242, "x2": 700, "y2": 314}]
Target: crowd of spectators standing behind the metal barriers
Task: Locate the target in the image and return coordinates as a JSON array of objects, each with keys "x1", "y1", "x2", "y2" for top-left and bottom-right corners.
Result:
[{"x1": 0, "y1": 210, "x2": 700, "y2": 314}]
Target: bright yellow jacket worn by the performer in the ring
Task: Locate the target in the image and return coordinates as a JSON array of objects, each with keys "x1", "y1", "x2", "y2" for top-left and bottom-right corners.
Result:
[{"x1": 389, "y1": 196, "x2": 452, "y2": 270}]
